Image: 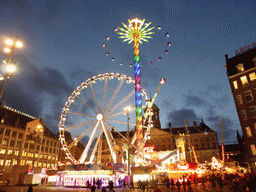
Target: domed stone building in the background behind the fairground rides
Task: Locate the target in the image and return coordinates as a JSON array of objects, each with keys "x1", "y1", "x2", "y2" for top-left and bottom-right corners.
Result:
[{"x1": 95, "y1": 105, "x2": 219, "y2": 163}]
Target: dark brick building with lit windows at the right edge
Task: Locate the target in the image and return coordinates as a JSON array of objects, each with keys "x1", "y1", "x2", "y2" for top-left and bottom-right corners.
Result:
[{"x1": 225, "y1": 42, "x2": 256, "y2": 171}]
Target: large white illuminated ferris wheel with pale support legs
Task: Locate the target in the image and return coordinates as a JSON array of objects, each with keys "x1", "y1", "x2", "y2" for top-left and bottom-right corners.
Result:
[{"x1": 59, "y1": 73, "x2": 151, "y2": 163}]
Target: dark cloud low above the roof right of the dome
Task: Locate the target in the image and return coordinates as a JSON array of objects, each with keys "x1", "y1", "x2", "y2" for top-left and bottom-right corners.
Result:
[{"x1": 169, "y1": 108, "x2": 200, "y2": 127}]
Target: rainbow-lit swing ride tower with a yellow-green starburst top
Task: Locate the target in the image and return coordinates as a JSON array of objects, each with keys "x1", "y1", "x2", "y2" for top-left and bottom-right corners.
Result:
[{"x1": 116, "y1": 18, "x2": 154, "y2": 158}]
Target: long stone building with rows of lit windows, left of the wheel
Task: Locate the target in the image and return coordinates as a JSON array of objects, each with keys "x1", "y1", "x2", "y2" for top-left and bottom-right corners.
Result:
[{"x1": 0, "y1": 103, "x2": 60, "y2": 185}]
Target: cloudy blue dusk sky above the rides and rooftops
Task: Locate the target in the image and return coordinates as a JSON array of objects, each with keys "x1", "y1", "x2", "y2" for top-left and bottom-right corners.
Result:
[{"x1": 0, "y1": 0, "x2": 256, "y2": 142}]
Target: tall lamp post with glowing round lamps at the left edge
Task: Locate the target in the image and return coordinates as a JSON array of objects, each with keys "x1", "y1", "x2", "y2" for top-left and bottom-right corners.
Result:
[{"x1": 0, "y1": 37, "x2": 23, "y2": 99}]
